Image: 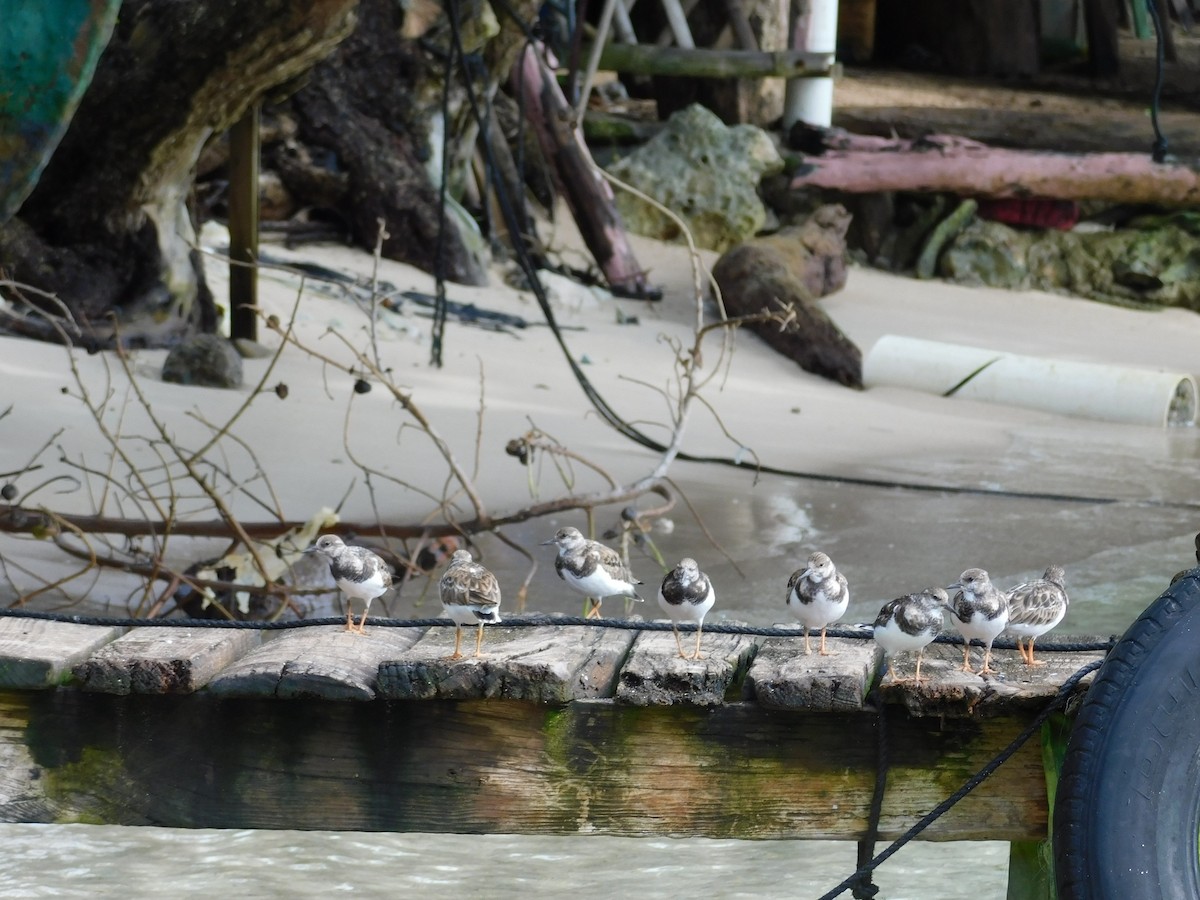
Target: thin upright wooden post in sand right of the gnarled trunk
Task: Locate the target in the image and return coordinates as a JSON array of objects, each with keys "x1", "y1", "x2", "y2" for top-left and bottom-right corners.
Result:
[{"x1": 229, "y1": 102, "x2": 260, "y2": 341}]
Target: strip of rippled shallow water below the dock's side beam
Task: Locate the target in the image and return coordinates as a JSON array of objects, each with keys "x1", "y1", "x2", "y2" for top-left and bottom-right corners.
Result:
[{"x1": 0, "y1": 824, "x2": 1008, "y2": 900}]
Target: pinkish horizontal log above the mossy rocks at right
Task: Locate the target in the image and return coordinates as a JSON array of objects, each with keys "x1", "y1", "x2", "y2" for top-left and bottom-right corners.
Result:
[{"x1": 792, "y1": 132, "x2": 1200, "y2": 206}]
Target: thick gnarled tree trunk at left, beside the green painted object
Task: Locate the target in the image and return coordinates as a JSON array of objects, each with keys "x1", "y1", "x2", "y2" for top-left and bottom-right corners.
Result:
[{"x1": 0, "y1": 0, "x2": 356, "y2": 346}]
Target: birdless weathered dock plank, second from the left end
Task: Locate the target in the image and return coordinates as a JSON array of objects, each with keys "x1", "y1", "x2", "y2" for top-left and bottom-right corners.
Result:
[{"x1": 73, "y1": 628, "x2": 263, "y2": 694}]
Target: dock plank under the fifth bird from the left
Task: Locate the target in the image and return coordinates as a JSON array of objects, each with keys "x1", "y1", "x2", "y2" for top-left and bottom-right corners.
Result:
[{"x1": 746, "y1": 626, "x2": 878, "y2": 710}]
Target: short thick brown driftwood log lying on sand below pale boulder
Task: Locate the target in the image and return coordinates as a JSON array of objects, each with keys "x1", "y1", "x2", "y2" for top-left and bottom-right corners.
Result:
[{"x1": 713, "y1": 206, "x2": 863, "y2": 388}]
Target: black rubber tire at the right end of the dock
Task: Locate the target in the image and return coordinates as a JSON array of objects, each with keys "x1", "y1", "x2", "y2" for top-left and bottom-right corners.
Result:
[{"x1": 1054, "y1": 569, "x2": 1200, "y2": 900}]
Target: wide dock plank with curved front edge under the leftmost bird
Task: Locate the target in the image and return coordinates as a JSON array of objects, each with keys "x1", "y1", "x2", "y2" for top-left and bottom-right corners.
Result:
[{"x1": 208, "y1": 624, "x2": 424, "y2": 700}]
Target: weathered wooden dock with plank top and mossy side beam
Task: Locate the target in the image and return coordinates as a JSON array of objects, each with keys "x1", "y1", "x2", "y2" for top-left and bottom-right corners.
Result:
[{"x1": 0, "y1": 617, "x2": 1103, "y2": 897}]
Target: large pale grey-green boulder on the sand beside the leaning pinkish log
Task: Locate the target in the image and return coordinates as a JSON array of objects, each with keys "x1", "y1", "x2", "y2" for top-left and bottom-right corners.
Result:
[{"x1": 608, "y1": 104, "x2": 784, "y2": 251}]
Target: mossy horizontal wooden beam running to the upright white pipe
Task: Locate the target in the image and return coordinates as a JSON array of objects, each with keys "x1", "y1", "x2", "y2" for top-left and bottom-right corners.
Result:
[{"x1": 590, "y1": 43, "x2": 834, "y2": 78}]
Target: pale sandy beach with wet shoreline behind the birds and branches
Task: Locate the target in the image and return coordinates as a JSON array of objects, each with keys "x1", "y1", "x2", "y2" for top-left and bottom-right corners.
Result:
[{"x1": 0, "y1": 210, "x2": 1200, "y2": 633}]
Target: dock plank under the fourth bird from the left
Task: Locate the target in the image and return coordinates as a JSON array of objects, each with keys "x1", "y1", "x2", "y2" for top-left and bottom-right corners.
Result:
[{"x1": 617, "y1": 631, "x2": 757, "y2": 707}]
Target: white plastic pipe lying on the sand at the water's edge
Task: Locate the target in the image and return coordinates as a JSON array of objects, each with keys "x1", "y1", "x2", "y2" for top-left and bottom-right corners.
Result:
[{"x1": 863, "y1": 335, "x2": 1198, "y2": 427}]
